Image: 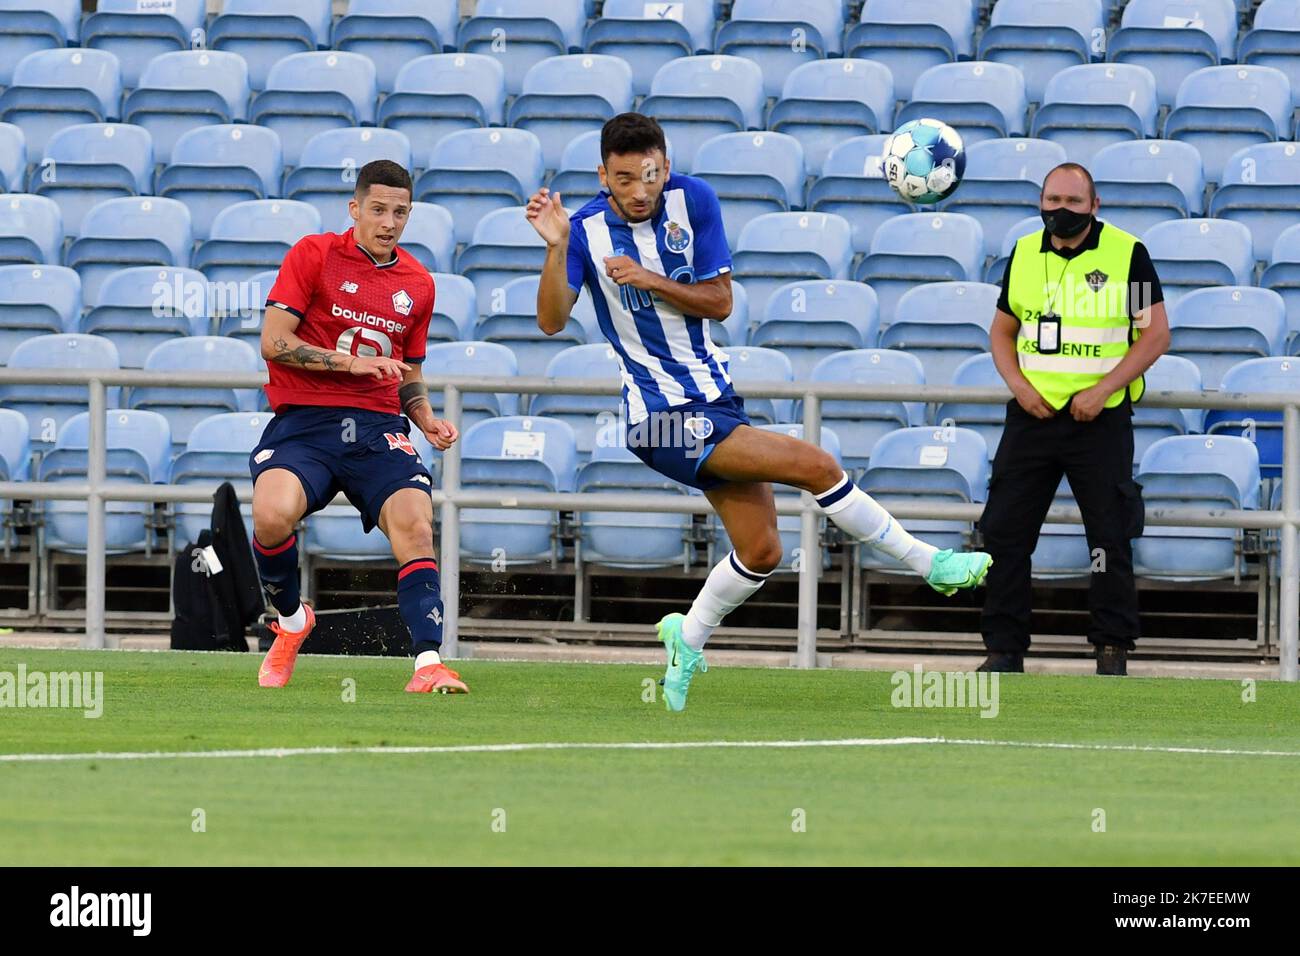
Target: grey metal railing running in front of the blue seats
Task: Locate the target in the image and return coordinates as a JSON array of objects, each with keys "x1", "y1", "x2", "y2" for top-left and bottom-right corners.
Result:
[{"x1": 0, "y1": 368, "x2": 1300, "y2": 682}]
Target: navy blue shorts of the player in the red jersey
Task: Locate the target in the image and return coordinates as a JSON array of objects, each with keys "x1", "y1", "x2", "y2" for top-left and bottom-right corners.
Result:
[{"x1": 248, "y1": 405, "x2": 433, "y2": 533}]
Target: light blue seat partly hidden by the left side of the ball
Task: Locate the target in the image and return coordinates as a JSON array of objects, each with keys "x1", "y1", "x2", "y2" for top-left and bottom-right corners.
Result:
[{"x1": 807, "y1": 133, "x2": 911, "y2": 252}]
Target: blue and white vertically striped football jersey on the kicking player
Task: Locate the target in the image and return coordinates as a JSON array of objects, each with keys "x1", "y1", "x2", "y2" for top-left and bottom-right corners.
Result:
[{"x1": 567, "y1": 173, "x2": 732, "y2": 424}]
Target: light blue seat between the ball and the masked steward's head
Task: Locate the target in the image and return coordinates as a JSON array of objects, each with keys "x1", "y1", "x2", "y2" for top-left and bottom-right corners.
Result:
[{"x1": 940, "y1": 138, "x2": 1066, "y2": 256}]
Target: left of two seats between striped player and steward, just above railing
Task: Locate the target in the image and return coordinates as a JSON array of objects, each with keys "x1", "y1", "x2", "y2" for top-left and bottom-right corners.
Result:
[{"x1": 749, "y1": 280, "x2": 880, "y2": 381}]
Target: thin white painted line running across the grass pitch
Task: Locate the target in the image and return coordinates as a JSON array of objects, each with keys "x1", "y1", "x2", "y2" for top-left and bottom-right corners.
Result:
[{"x1": 0, "y1": 737, "x2": 1300, "y2": 763}]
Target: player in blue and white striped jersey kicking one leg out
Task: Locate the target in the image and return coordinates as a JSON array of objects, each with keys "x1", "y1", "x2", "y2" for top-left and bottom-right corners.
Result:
[{"x1": 527, "y1": 113, "x2": 991, "y2": 710}]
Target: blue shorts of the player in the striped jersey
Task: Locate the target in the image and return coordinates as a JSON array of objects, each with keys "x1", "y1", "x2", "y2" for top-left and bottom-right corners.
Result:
[{"x1": 625, "y1": 393, "x2": 749, "y2": 492}]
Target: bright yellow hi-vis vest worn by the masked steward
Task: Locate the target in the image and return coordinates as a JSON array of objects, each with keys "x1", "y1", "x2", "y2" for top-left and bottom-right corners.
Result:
[{"x1": 1008, "y1": 222, "x2": 1145, "y2": 411}]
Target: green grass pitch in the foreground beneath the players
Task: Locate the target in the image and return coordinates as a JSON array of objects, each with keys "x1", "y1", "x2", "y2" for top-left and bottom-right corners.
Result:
[{"x1": 0, "y1": 648, "x2": 1300, "y2": 865}]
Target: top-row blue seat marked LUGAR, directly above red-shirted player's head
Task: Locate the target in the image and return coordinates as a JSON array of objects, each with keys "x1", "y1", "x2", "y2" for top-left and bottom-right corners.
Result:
[{"x1": 333, "y1": 0, "x2": 460, "y2": 92}]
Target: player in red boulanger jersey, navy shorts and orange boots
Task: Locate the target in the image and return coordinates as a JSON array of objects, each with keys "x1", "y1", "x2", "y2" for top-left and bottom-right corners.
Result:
[{"x1": 248, "y1": 160, "x2": 468, "y2": 693}]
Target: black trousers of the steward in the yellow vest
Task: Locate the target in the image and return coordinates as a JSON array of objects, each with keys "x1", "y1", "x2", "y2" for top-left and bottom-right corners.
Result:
[{"x1": 979, "y1": 399, "x2": 1144, "y2": 653}]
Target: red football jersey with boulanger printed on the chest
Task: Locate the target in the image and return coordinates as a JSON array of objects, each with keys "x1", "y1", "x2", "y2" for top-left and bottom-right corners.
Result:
[{"x1": 267, "y1": 229, "x2": 434, "y2": 415}]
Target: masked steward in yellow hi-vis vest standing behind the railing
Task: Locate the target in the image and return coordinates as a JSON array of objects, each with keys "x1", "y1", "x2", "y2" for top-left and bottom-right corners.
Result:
[{"x1": 978, "y1": 163, "x2": 1169, "y2": 675}]
